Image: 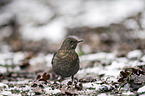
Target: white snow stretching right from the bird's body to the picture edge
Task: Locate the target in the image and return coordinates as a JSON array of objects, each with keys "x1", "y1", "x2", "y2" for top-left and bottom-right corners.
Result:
[{"x1": 77, "y1": 50, "x2": 144, "y2": 81}]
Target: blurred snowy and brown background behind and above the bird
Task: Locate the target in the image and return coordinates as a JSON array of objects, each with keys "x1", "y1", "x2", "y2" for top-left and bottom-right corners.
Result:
[{"x1": 0, "y1": 0, "x2": 145, "y2": 55}]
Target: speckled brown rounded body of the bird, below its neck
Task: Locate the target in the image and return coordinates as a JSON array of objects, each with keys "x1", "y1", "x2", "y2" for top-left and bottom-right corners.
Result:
[{"x1": 52, "y1": 50, "x2": 79, "y2": 77}]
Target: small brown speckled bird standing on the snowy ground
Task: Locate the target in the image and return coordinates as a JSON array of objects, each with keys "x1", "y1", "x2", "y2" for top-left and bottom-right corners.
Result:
[{"x1": 51, "y1": 36, "x2": 83, "y2": 82}]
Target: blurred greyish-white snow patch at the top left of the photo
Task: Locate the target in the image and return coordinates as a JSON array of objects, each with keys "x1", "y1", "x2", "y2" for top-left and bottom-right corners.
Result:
[{"x1": 5, "y1": 0, "x2": 54, "y2": 25}]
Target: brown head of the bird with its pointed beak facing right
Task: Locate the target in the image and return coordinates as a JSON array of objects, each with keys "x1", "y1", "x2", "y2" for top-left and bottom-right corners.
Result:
[{"x1": 60, "y1": 37, "x2": 83, "y2": 50}]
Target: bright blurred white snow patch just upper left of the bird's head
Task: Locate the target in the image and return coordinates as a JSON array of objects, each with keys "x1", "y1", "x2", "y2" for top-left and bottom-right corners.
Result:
[{"x1": 21, "y1": 18, "x2": 66, "y2": 42}]
